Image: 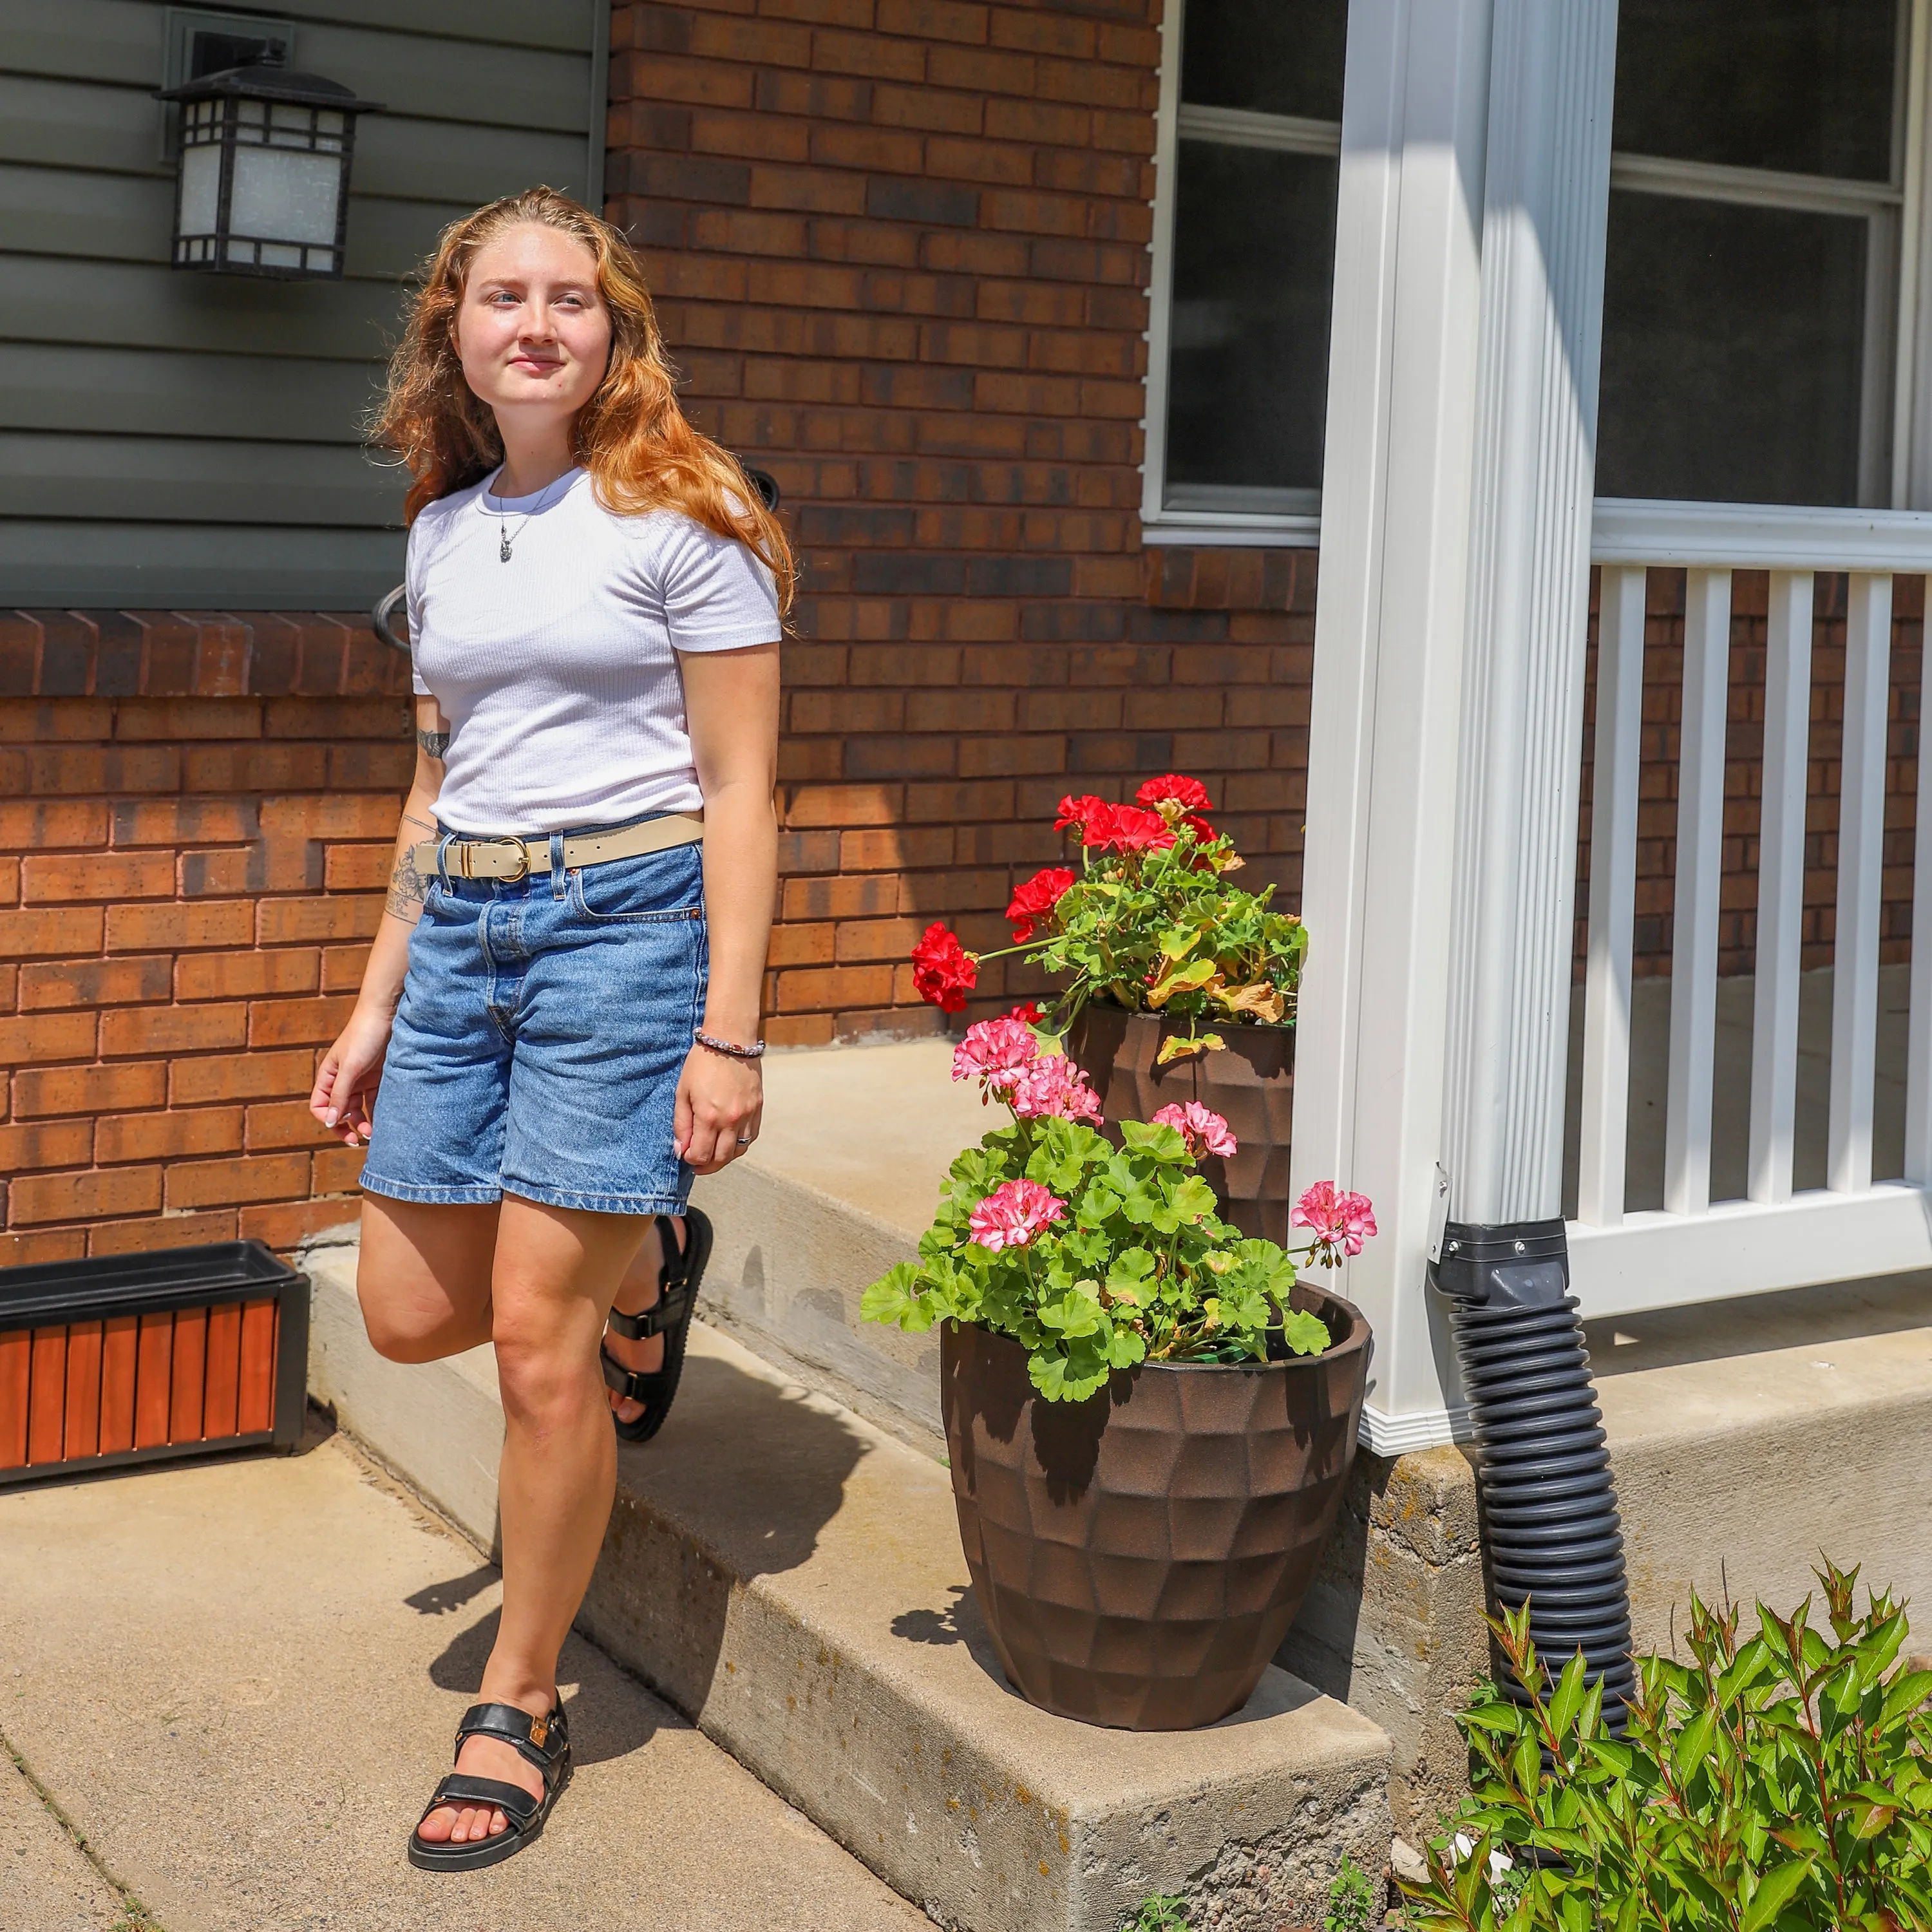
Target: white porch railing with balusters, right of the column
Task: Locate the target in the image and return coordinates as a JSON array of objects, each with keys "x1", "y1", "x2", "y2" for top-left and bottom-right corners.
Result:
[{"x1": 1571, "y1": 522, "x2": 1932, "y2": 1316}]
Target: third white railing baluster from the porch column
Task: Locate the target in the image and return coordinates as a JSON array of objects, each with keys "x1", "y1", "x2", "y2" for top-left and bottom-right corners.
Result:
[{"x1": 1748, "y1": 570, "x2": 1812, "y2": 1202}]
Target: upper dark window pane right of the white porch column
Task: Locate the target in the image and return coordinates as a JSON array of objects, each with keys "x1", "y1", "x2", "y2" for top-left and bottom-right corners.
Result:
[{"x1": 1607, "y1": 0, "x2": 1899, "y2": 182}]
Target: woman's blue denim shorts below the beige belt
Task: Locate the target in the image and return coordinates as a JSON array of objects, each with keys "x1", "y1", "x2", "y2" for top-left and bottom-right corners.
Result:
[{"x1": 361, "y1": 823, "x2": 709, "y2": 1213}]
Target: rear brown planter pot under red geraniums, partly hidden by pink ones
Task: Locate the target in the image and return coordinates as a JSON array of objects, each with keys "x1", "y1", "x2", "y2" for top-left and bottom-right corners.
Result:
[{"x1": 1066, "y1": 1001, "x2": 1294, "y2": 1246}]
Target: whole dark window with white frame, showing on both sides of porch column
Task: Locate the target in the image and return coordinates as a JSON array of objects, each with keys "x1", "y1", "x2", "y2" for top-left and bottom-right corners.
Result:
[{"x1": 1142, "y1": 0, "x2": 1932, "y2": 543}]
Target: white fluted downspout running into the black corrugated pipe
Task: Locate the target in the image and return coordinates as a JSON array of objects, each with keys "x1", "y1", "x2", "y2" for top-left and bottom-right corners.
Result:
[{"x1": 1443, "y1": 0, "x2": 1617, "y2": 1225}]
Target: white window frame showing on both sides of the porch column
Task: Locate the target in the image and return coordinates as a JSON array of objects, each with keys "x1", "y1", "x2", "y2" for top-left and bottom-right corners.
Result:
[{"x1": 1140, "y1": 0, "x2": 1932, "y2": 556}]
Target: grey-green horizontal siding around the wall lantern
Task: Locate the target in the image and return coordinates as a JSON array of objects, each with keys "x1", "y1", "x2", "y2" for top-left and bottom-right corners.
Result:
[{"x1": 0, "y1": 0, "x2": 605, "y2": 609}]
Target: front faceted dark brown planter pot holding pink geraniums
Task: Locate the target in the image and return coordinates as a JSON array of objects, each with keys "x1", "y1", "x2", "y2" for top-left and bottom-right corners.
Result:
[{"x1": 939, "y1": 1285, "x2": 1370, "y2": 1731}]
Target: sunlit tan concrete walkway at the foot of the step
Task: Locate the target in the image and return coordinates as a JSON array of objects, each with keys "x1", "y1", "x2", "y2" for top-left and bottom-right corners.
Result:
[{"x1": 0, "y1": 1434, "x2": 929, "y2": 1932}]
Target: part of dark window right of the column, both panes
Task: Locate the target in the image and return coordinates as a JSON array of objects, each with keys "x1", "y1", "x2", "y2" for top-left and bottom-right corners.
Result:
[{"x1": 1598, "y1": 0, "x2": 1911, "y2": 506}]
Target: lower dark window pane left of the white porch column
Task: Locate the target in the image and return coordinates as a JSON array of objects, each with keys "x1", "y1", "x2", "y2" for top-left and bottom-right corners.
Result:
[{"x1": 1167, "y1": 143, "x2": 1337, "y2": 508}]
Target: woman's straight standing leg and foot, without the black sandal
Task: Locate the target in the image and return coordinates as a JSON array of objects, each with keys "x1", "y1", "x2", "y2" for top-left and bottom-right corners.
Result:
[{"x1": 421, "y1": 1194, "x2": 649, "y2": 1843}]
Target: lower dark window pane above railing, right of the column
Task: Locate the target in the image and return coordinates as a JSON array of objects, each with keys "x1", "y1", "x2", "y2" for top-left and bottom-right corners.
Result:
[{"x1": 1596, "y1": 193, "x2": 1870, "y2": 504}]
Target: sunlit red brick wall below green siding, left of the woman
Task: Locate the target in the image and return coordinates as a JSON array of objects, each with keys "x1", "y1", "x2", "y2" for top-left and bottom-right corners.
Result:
[{"x1": 0, "y1": 612, "x2": 413, "y2": 1264}]
